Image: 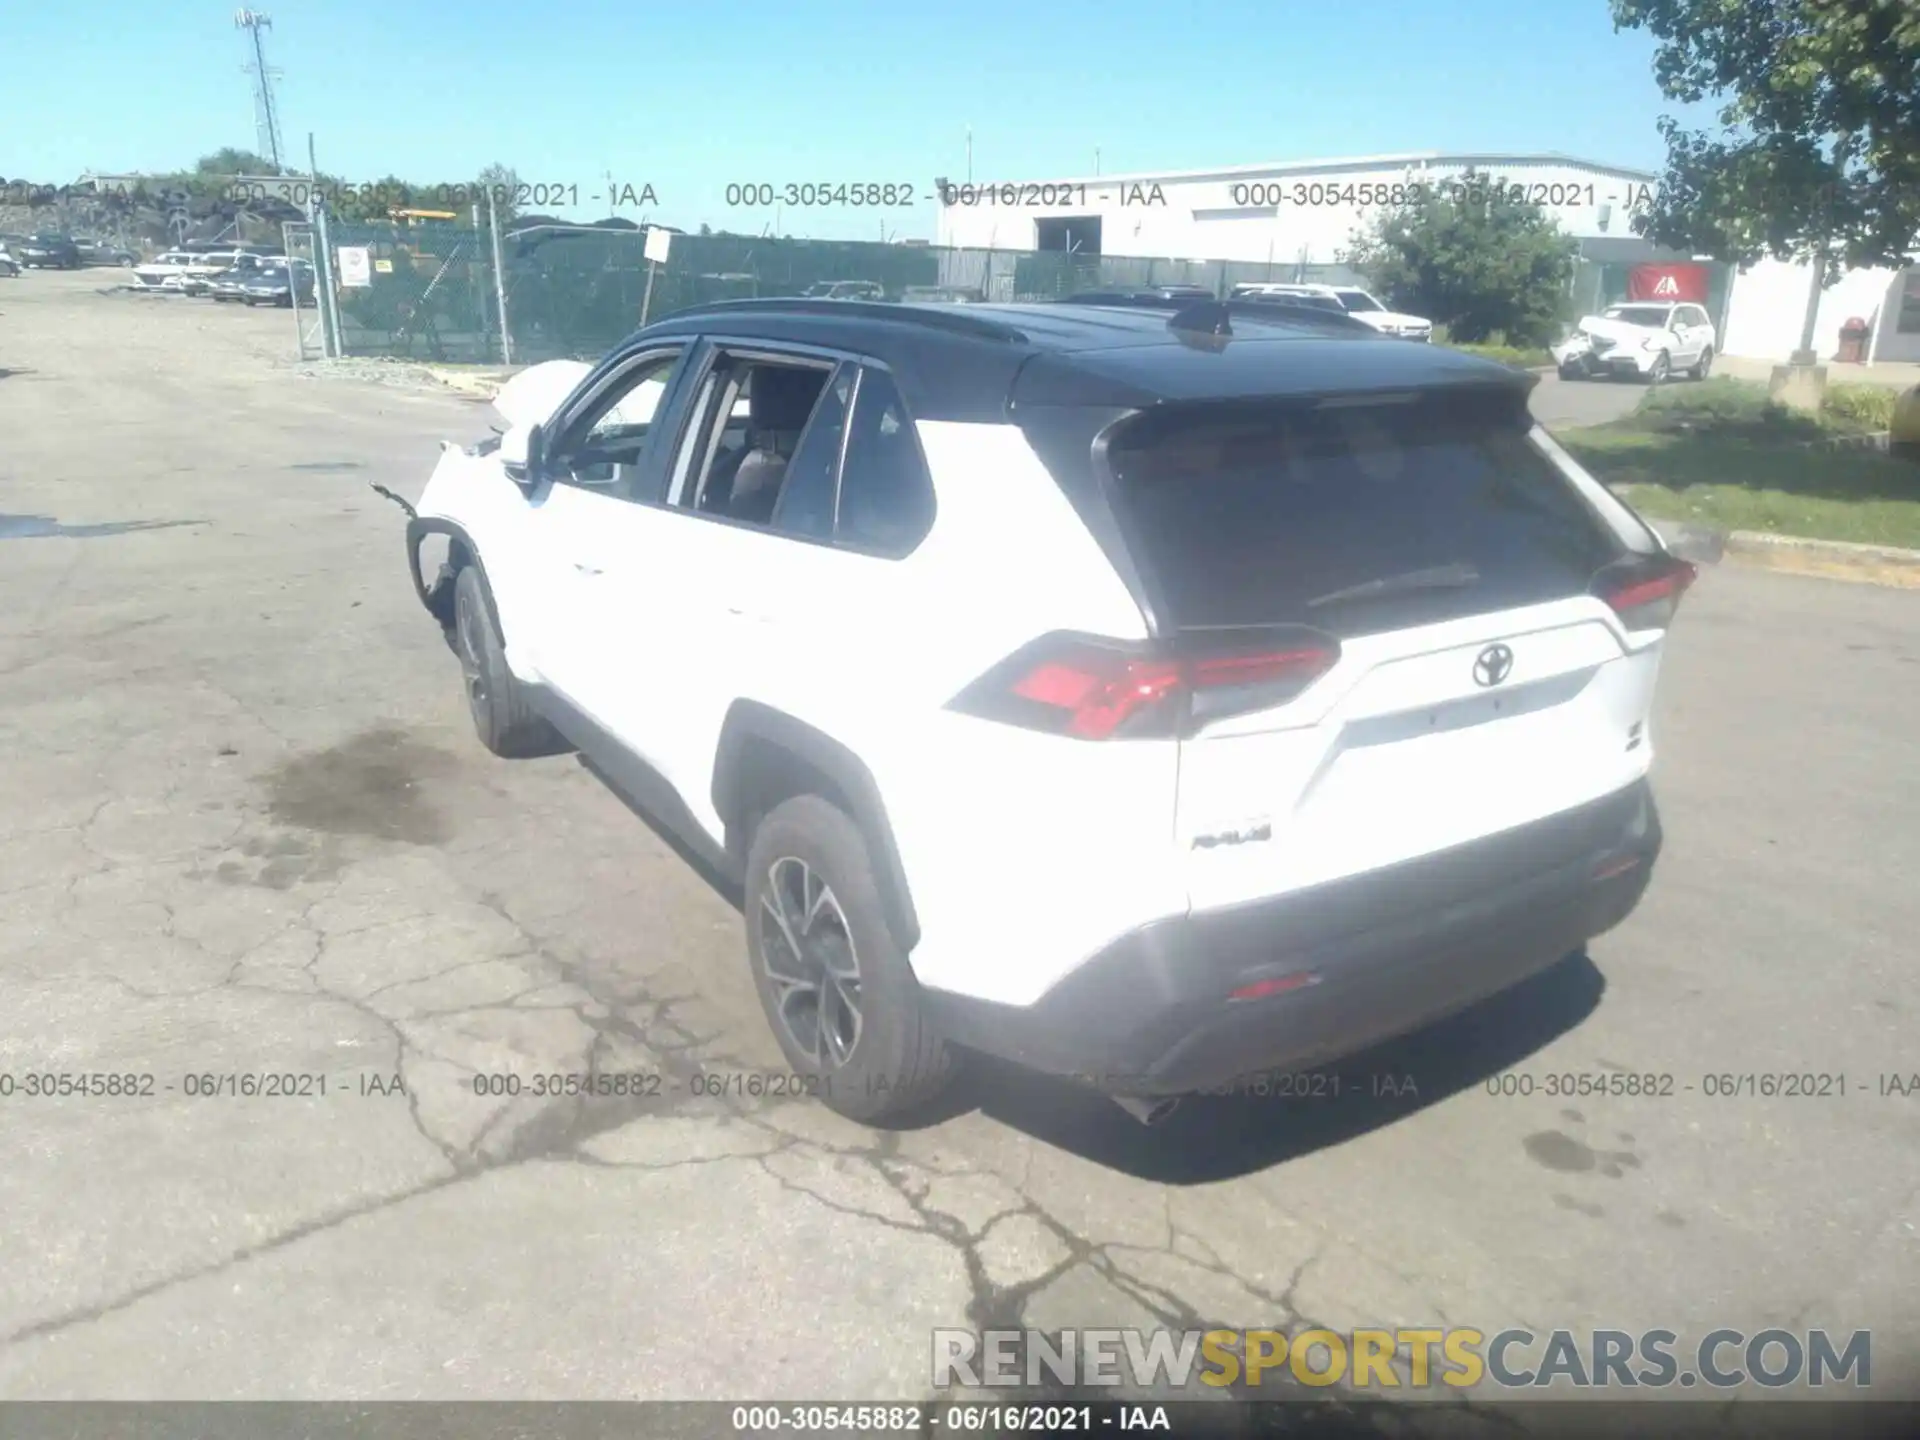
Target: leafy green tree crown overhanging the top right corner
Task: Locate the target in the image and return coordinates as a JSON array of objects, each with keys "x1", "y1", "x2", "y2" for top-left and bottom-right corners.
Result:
[{"x1": 1611, "y1": 0, "x2": 1920, "y2": 282}]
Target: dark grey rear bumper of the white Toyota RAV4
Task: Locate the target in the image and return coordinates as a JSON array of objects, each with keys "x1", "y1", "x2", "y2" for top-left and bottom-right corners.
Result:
[{"x1": 927, "y1": 781, "x2": 1661, "y2": 1094}]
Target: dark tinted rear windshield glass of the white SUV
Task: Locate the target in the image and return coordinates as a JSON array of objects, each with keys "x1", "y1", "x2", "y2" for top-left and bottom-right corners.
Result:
[{"x1": 1108, "y1": 403, "x2": 1619, "y2": 636}]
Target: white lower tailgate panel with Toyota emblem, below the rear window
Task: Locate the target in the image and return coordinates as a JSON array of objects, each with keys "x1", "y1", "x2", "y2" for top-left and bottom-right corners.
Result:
[{"x1": 1177, "y1": 601, "x2": 1655, "y2": 908}]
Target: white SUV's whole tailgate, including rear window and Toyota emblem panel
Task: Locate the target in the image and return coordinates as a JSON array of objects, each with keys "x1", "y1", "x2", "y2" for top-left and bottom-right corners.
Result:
[{"x1": 1108, "y1": 378, "x2": 1659, "y2": 908}]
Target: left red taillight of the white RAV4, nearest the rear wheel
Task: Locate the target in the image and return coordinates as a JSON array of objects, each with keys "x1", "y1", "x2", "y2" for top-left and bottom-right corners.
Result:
[{"x1": 952, "y1": 636, "x2": 1340, "y2": 739}]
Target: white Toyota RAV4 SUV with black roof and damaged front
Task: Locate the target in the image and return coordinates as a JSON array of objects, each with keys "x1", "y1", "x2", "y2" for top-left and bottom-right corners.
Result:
[{"x1": 393, "y1": 298, "x2": 1693, "y2": 1121}]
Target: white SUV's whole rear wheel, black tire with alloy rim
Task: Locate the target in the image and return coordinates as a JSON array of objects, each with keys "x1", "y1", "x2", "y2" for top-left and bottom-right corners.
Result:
[{"x1": 745, "y1": 795, "x2": 956, "y2": 1123}]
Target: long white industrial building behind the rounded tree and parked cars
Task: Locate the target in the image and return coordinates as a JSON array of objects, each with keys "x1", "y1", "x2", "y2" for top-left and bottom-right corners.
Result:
[{"x1": 935, "y1": 152, "x2": 1920, "y2": 361}]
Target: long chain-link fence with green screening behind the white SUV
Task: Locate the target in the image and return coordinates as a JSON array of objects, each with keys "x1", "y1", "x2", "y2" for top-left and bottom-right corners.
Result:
[{"x1": 311, "y1": 219, "x2": 1357, "y2": 365}]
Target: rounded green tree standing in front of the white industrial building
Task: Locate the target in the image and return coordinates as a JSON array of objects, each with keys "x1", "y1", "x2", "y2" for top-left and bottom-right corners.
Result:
[{"x1": 1344, "y1": 171, "x2": 1578, "y2": 346}]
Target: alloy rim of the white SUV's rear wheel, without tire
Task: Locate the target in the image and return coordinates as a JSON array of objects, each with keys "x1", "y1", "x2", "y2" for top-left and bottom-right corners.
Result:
[{"x1": 760, "y1": 854, "x2": 860, "y2": 1069}]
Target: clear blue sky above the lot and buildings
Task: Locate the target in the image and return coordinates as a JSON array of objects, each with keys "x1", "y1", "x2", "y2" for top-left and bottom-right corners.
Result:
[{"x1": 0, "y1": 0, "x2": 1712, "y2": 238}]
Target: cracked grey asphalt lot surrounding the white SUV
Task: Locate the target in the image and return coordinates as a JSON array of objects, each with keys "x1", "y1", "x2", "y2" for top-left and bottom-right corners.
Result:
[{"x1": 0, "y1": 273, "x2": 1920, "y2": 1400}]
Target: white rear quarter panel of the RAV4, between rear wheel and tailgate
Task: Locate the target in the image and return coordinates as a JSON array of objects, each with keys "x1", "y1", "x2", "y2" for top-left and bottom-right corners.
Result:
[{"x1": 833, "y1": 422, "x2": 1185, "y2": 1004}]
